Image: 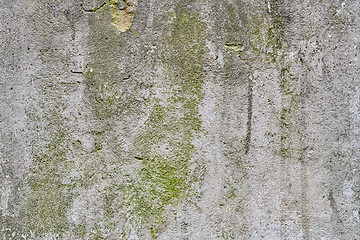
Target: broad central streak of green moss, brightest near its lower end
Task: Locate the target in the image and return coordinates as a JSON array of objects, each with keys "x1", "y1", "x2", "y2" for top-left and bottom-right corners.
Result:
[{"x1": 121, "y1": 4, "x2": 205, "y2": 238}]
